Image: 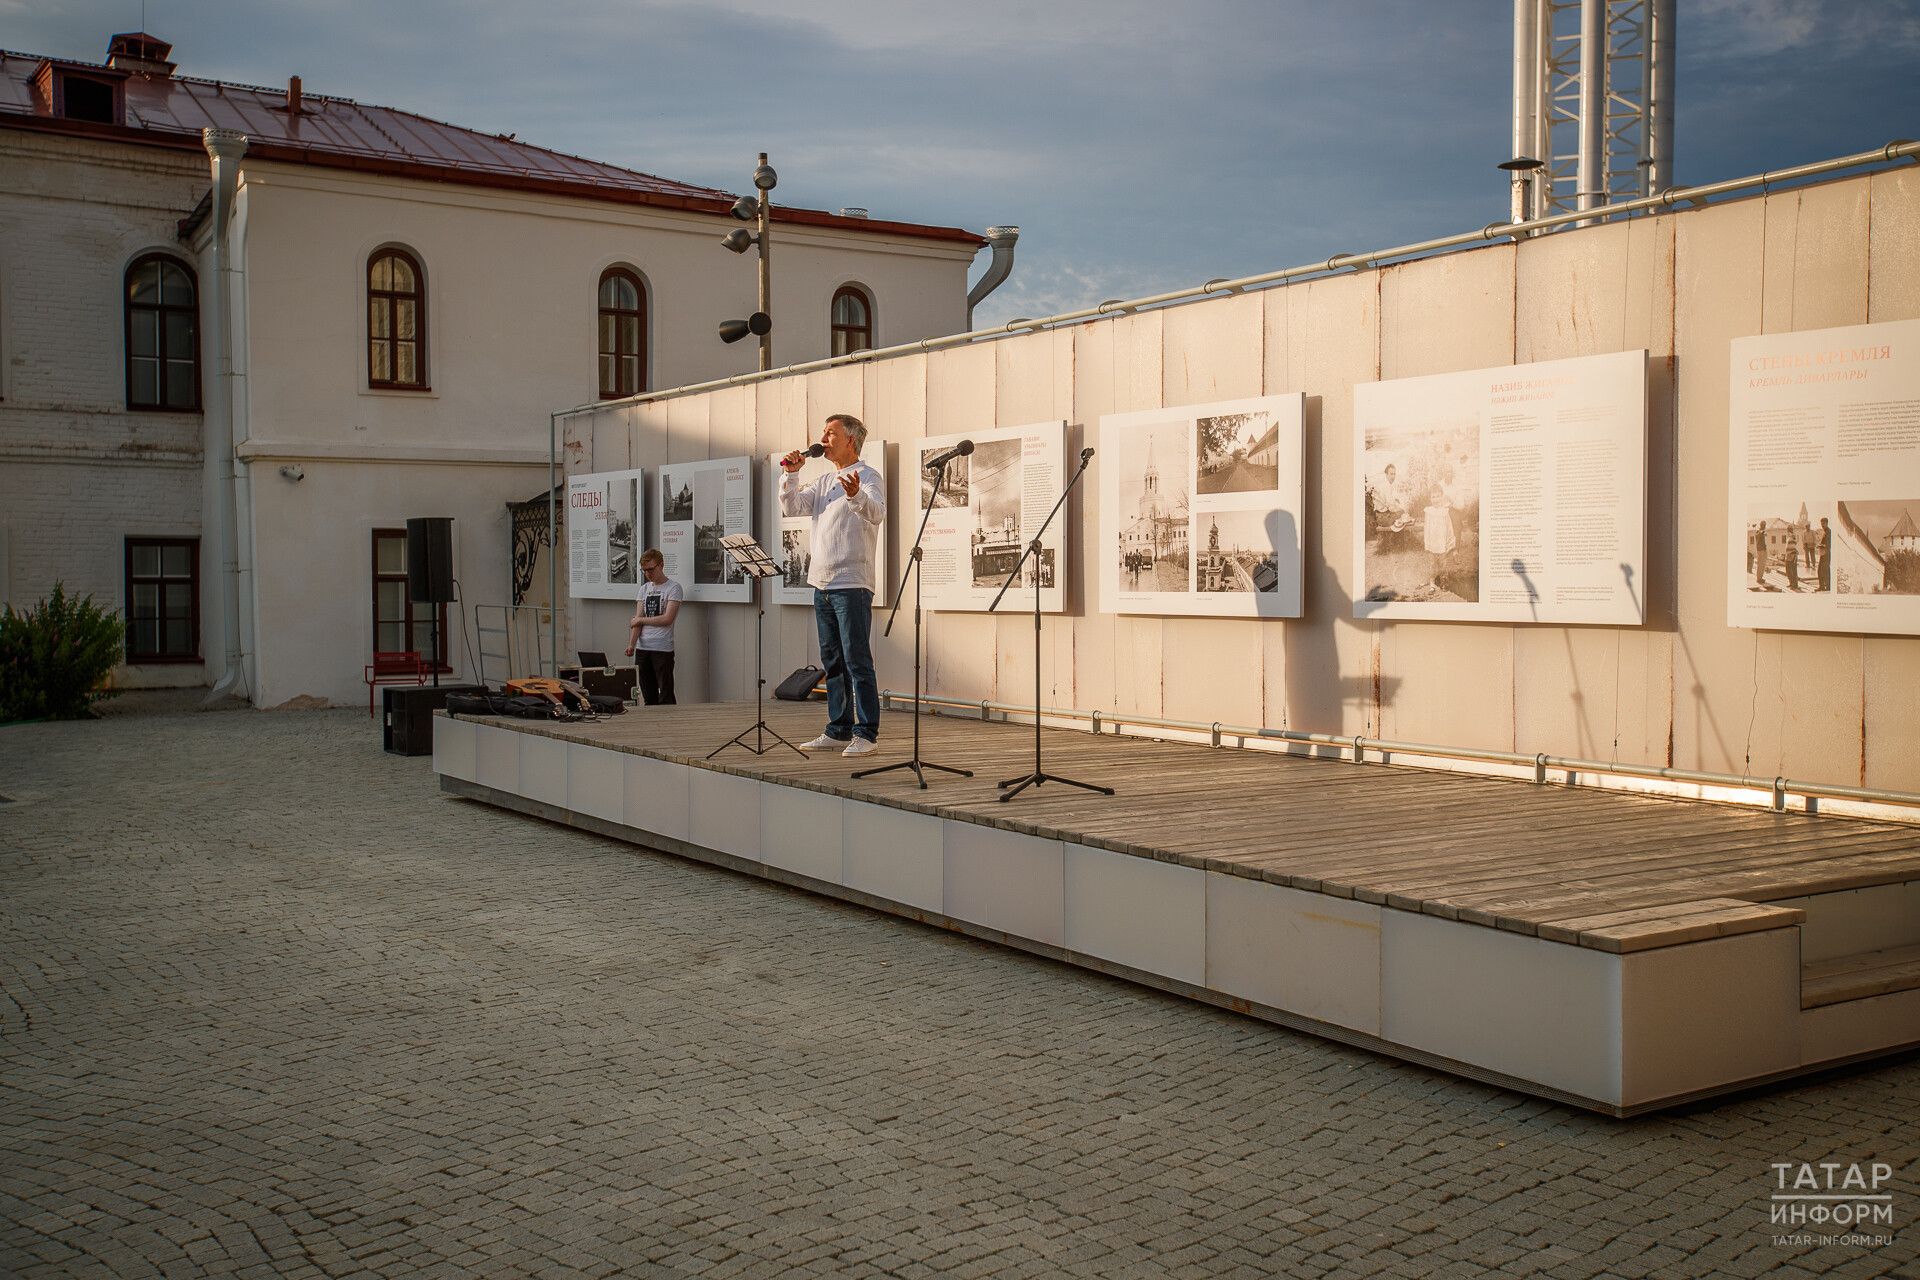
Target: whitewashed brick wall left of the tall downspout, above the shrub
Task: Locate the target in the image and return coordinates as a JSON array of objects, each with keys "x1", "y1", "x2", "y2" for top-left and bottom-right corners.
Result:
[{"x1": 0, "y1": 130, "x2": 207, "y2": 685}]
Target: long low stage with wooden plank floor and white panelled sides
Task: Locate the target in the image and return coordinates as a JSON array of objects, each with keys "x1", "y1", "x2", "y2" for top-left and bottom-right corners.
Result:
[{"x1": 434, "y1": 702, "x2": 1920, "y2": 1115}]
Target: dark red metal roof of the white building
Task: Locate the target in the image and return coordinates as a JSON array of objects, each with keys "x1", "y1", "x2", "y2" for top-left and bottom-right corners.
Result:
[{"x1": 0, "y1": 46, "x2": 987, "y2": 248}]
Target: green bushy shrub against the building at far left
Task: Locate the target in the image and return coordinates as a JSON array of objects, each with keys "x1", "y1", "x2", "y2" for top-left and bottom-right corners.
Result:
[{"x1": 0, "y1": 581, "x2": 127, "y2": 722}]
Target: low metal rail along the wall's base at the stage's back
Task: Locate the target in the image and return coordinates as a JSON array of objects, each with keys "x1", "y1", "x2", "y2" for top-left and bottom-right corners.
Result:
[{"x1": 879, "y1": 689, "x2": 1920, "y2": 821}]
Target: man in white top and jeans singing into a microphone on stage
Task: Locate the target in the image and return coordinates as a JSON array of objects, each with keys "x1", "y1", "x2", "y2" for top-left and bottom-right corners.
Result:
[{"x1": 780, "y1": 413, "x2": 887, "y2": 756}]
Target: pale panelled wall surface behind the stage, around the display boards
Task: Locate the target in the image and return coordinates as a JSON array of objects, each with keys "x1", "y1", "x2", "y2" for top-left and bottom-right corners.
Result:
[{"x1": 564, "y1": 167, "x2": 1920, "y2": 791}]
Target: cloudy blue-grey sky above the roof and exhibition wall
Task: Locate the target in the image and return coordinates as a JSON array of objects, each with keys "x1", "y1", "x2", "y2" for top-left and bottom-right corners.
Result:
[{"x1": 15, "y1": 0, "x2": 1920, "y2": 326}]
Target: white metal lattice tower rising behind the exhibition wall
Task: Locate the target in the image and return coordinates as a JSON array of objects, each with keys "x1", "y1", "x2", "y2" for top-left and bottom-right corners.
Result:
[{"x1": 1503, "y1": 0, "x2": 1676, "y2": 221}]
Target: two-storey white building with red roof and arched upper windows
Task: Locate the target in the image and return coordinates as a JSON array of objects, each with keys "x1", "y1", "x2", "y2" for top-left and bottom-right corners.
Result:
[{"x1": 0, "y1": 36, "x2": 983, "y2": 706}]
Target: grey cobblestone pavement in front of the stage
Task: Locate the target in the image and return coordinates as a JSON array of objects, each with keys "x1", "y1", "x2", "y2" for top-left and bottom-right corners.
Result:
[{"x1": 0, "y1": 712, "x2": 1920, "y2": 1278}]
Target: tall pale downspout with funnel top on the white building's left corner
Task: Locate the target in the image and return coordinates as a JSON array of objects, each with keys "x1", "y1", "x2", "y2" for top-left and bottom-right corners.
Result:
[{"x1": 200, "y1": 129, "x2": 248, "y2": 702}]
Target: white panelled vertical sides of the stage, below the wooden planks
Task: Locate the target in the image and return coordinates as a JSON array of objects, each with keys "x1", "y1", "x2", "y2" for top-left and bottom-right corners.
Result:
[{"x1": 434, "y1": 718, "x2": 1920, "y2": 1115}]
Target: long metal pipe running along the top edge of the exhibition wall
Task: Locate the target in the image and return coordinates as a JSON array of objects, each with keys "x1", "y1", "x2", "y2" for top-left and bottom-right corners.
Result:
[{"x1": 553, "y1": 138, "x2": 1920, "y2": 418}]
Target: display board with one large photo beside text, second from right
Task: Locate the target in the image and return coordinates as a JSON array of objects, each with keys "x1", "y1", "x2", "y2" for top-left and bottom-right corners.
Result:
[{"x1": 1354, "y1": 351, "x2": 1647, "y2": 626}]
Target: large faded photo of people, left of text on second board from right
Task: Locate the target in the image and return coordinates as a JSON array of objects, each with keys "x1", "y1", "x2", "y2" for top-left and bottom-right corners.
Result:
[{"x1": 1361, "y1": 420, "x2": 1480, "y2": 604}]
